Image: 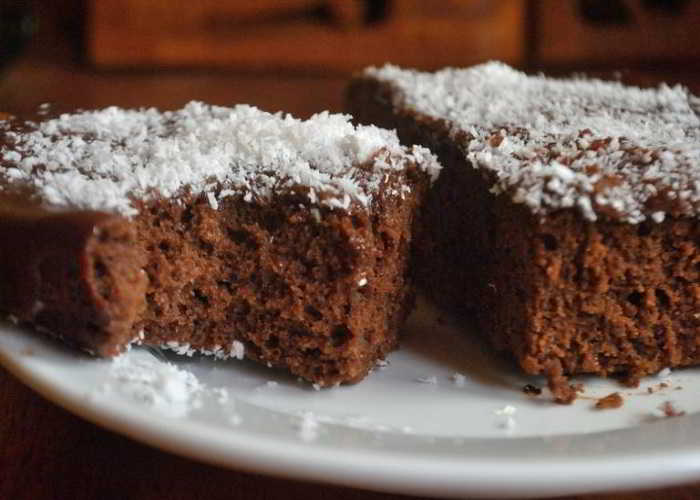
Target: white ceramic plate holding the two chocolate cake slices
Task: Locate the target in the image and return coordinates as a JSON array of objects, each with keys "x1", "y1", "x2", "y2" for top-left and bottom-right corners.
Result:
[{"x1": 0, "y1": 298, "x2": 700, "y2": 497}]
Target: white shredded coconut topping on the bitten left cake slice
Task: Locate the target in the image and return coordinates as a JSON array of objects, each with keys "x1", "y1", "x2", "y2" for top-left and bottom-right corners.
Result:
[{"x1": 0, "y1": 102, "x2": 439, "y2": 216}]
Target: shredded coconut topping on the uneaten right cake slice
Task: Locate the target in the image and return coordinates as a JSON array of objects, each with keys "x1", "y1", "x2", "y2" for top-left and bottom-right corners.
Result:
[{"x1": 366, "y1": 62, "x2": 700, "y2": 224}]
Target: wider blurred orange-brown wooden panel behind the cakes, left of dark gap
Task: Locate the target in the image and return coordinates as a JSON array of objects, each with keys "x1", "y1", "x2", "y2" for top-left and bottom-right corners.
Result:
[{"x1": 87, "y1": 0, "x2": 524, "y2": 72}]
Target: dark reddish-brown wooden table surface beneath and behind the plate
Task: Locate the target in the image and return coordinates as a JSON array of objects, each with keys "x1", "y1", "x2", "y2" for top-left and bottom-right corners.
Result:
[{"x1": 0, "y1": 29, "x2": 700, "y2": 500}]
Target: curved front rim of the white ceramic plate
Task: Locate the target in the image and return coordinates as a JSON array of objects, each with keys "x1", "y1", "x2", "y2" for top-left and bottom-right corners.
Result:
[{"x1": 0, "y1": 323, "x2": 700, "y2": 498}]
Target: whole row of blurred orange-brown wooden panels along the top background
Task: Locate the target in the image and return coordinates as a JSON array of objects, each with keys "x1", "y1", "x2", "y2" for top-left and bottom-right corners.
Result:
[{"x1": 86, "y1": 0, "x2": 700, "y2": 72}]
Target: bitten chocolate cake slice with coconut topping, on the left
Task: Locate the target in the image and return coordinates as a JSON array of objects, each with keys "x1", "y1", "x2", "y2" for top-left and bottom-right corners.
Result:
[{"x1": 0, "y1": 102, "x2": 440, "y2": 386}]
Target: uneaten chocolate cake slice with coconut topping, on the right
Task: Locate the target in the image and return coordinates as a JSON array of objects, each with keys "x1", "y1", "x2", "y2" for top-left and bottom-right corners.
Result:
[{"x1": 348, "y1": 62, "x2": 700, "y2": 402}]
